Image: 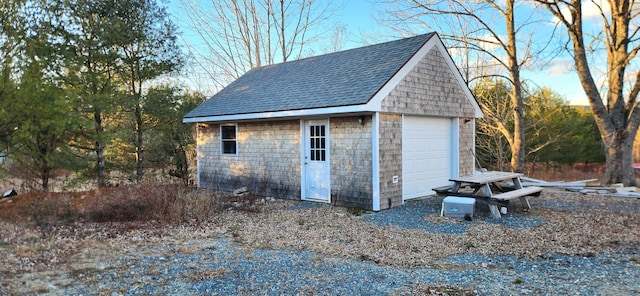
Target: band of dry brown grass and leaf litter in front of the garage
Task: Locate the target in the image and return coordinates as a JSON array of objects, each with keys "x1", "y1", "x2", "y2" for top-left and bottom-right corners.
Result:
[{"x1": 0, "y1": 184, "x2": 640, "y2": 295}]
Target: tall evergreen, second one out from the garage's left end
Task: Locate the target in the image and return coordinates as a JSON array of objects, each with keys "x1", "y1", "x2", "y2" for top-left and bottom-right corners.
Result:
[{"x1": 54, "y1": 0, "x2": 127, "y2": 186}]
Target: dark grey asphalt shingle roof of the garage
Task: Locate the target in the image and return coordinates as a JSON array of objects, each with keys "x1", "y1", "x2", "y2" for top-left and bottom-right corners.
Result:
[{"x1": 185, "y1": 33, "x2": 435, "y2": 118}]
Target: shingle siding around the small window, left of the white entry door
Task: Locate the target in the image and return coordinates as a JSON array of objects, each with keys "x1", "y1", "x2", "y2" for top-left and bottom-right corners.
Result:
[{"x1": 198, "y1": 120, "x2": 300, "y2": 199}]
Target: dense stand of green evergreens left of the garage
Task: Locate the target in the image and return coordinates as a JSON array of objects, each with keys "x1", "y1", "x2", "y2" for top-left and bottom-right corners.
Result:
[{"x1": 0, "y1": 0, "x2": 203, "y2": 190}]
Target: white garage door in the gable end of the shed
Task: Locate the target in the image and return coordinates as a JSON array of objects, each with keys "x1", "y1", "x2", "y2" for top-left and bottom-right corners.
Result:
[{"x1": 402, "y1": 116, "x2": 453, "y2": 200}]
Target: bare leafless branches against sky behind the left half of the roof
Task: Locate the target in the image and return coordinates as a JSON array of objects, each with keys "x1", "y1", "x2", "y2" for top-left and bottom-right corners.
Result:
[{"x1": 181, "y1": 0, "x2": 334, "y2": 87}]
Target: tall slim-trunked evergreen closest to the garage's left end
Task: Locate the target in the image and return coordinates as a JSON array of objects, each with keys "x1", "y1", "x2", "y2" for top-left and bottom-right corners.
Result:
[{"x1": 111, "y1": 0, "x2": 182, "y2": 182}]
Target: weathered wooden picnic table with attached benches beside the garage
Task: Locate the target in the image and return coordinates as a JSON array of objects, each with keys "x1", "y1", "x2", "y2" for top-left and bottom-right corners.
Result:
[{"x1": 434, "y1": 171, "x2": 542, "y2": 218}]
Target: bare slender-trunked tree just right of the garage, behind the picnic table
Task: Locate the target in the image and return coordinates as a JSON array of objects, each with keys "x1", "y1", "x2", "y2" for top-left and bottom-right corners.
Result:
[{"x1": 380, "y1": 0, "x2": 551, "y2": 171}]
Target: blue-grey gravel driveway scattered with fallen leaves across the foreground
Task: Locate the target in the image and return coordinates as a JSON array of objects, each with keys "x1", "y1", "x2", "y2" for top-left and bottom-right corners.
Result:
[{"x1": 0, "y1": 194, "x2": 640, "y2": 295}]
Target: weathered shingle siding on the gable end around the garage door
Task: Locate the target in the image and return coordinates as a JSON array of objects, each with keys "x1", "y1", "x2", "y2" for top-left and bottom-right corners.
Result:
[{"x1": 380, "y1": 49, "x2": 475, "y2": 209}]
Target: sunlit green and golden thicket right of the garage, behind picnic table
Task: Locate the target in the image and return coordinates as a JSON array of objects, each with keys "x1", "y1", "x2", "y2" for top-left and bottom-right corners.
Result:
[{"x1": 473, "y1": 79, "x2": 605, "y2": 169}]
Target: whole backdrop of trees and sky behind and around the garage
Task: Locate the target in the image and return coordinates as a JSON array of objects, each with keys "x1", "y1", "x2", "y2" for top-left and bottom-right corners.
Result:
[{"x1": 0, "y1": 0, "x2": 640, "y2": 191}]
